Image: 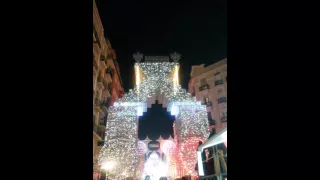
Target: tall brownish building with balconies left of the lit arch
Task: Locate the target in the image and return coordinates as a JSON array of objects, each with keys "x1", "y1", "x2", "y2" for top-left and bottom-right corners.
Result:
[{"x1": 93, "y1": 1, "x2": 124, "y2": 180}]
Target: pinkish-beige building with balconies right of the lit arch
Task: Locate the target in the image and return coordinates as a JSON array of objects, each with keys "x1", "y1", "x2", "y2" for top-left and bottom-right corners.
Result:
[{"x1": 188, "y1": 59, "x2": 227, "y2": 132}]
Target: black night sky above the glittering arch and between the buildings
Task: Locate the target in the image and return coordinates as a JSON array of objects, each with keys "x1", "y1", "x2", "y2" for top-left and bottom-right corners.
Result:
[{"x1": 96, "y1": 0, "x2": 227, "y2": 136}]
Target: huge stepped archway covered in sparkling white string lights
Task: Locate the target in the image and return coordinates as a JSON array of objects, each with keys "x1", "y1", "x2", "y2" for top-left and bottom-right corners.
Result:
[{"x1": 99, "y1": 53, "x2": 209, "y2": 179}]
